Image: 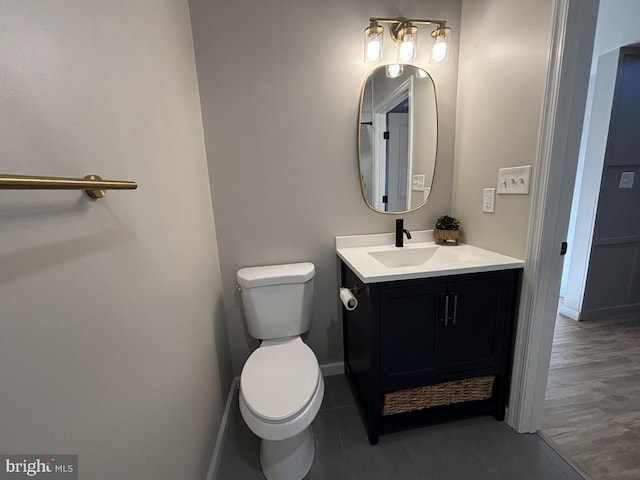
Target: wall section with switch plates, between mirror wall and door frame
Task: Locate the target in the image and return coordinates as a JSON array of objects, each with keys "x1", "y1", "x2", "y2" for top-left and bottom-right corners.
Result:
[{"x1": 453, "y1": 0, "x2": 553, "y2": 258}]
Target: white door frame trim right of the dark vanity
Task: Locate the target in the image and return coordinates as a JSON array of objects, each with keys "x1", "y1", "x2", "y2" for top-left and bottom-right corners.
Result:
[{"x1": 507, "y1": 0, "x2": 599, "y2": 433}]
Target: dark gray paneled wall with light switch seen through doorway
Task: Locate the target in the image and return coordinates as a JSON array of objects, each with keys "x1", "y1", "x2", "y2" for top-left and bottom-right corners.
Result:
[{"x1": 581, "y1": 47, "x2": 640, "y2": 318}]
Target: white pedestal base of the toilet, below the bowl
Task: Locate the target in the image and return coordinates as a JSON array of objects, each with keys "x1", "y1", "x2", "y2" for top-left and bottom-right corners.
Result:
[{"x1": 260, "y1": 425, "x2": 315, "y2": 480}]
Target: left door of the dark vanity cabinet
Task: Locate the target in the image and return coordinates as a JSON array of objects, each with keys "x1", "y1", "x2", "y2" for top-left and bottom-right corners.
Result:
[{"x1": 380, "y1": 282, "x2": 446, "y2": 390}]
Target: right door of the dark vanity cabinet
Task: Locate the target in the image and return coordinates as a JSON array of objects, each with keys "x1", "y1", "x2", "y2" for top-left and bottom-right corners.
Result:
[{"x1": 437, "y1": 275, "x2": 509, "y2": 372}]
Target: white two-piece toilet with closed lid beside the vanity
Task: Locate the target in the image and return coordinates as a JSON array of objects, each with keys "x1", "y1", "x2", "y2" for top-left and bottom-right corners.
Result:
[{"x1": 237, "y1": 262, "x2": 324, "y2": 480}]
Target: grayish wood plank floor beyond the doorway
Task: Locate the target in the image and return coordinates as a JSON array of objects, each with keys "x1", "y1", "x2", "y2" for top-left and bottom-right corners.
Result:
[{"x1": 540, "y1": 315, "x2": 640, "y2": 480}]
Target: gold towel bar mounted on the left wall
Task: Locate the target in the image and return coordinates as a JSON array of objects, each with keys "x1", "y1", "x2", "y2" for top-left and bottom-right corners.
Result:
[{"x1": 0, "y1": 173, "x2": 138, "y2": 198}]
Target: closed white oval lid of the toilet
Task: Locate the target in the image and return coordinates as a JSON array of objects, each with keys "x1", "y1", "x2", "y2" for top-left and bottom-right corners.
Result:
[{"x1": 240, "y1": 338, "x2": 320, "y2": 421}]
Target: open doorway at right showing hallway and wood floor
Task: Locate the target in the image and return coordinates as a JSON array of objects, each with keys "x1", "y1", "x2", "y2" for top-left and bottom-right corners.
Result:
[{"x1": 540, "y1": 0, "x2": 640, "y2": 479}]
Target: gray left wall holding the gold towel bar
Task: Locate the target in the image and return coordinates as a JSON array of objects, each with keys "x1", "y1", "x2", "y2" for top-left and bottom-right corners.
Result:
[{"x1": 0, "y1": 0, "x2": 231, "y2": 480}]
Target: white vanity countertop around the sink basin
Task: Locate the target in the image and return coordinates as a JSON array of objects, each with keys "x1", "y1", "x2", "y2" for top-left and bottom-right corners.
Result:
[{"x1": 336, "y1": 230, "x2": 524, "y2": 283}]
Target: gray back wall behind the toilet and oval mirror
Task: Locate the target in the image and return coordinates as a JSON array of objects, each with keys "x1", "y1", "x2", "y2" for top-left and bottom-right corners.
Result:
[{"x1": 190, "y1": 0, "x2": 460, "y2": 374}]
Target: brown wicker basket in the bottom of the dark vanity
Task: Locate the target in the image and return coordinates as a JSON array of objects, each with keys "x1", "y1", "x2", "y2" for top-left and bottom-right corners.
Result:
[{"x1": 382, "y1": 375, "x2": 495, "y2": 416}]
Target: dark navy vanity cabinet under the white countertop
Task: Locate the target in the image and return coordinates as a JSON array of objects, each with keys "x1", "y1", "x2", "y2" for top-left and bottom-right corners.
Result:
[{"x1": 341, "y1": 262, "x2": 521, "y2": 444}]
